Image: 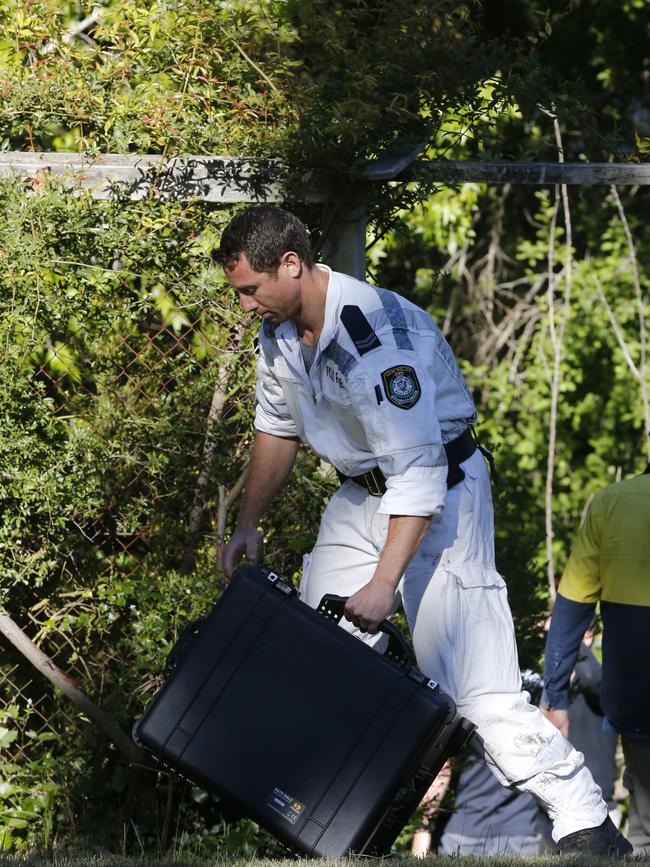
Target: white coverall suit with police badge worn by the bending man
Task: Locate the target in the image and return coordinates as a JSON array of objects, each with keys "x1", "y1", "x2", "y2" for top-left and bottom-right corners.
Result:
[{"x1": 255, "y1": 266, "x2": 607, "y2": 840}]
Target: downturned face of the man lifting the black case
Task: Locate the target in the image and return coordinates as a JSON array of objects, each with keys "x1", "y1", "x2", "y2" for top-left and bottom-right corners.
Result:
[{"x1": 225, "y1": 253, "x2": 300, "y2": 322}]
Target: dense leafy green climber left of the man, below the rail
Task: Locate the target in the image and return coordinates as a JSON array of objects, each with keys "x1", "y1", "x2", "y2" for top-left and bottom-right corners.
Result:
[{"x1": 0, "y1": 184, "x2": 230, "y2": 846}]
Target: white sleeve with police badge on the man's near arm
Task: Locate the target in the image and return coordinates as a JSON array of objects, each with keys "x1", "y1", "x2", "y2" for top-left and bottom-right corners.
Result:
[{"x1": 348, "y1": 352, "x2": 447, "y2": 516}]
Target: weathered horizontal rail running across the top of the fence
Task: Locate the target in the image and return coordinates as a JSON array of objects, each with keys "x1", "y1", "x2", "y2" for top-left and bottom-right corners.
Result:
[{"x1": 0, "y1": 151, "x2": 650, "y2": 204}]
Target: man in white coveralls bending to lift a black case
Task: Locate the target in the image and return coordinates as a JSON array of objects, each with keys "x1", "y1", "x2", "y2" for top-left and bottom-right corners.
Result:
[{"x1": 214, "y1": 205, "x2": 631, "y2": 855}]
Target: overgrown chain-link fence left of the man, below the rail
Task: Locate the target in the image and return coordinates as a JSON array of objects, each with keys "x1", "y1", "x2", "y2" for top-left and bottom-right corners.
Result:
[{"x1": 0, "y1": 182, "x2": 331, "y2": 851}]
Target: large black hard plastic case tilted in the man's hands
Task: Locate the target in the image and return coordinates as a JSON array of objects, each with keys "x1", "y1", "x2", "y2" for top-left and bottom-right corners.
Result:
[{"x1": 134, "y1": 566, "x2": 473, "y2": 858}]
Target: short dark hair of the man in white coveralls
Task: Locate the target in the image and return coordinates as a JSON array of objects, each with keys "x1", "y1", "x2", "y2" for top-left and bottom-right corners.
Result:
[{"x1": 212, "y1": 205, "x2": 312, "y2": 274}]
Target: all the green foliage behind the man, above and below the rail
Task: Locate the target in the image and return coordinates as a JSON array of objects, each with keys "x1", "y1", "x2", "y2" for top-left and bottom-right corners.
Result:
[{"x1": 0, "y1": 0, "x2": 650, "y2": 863}]
